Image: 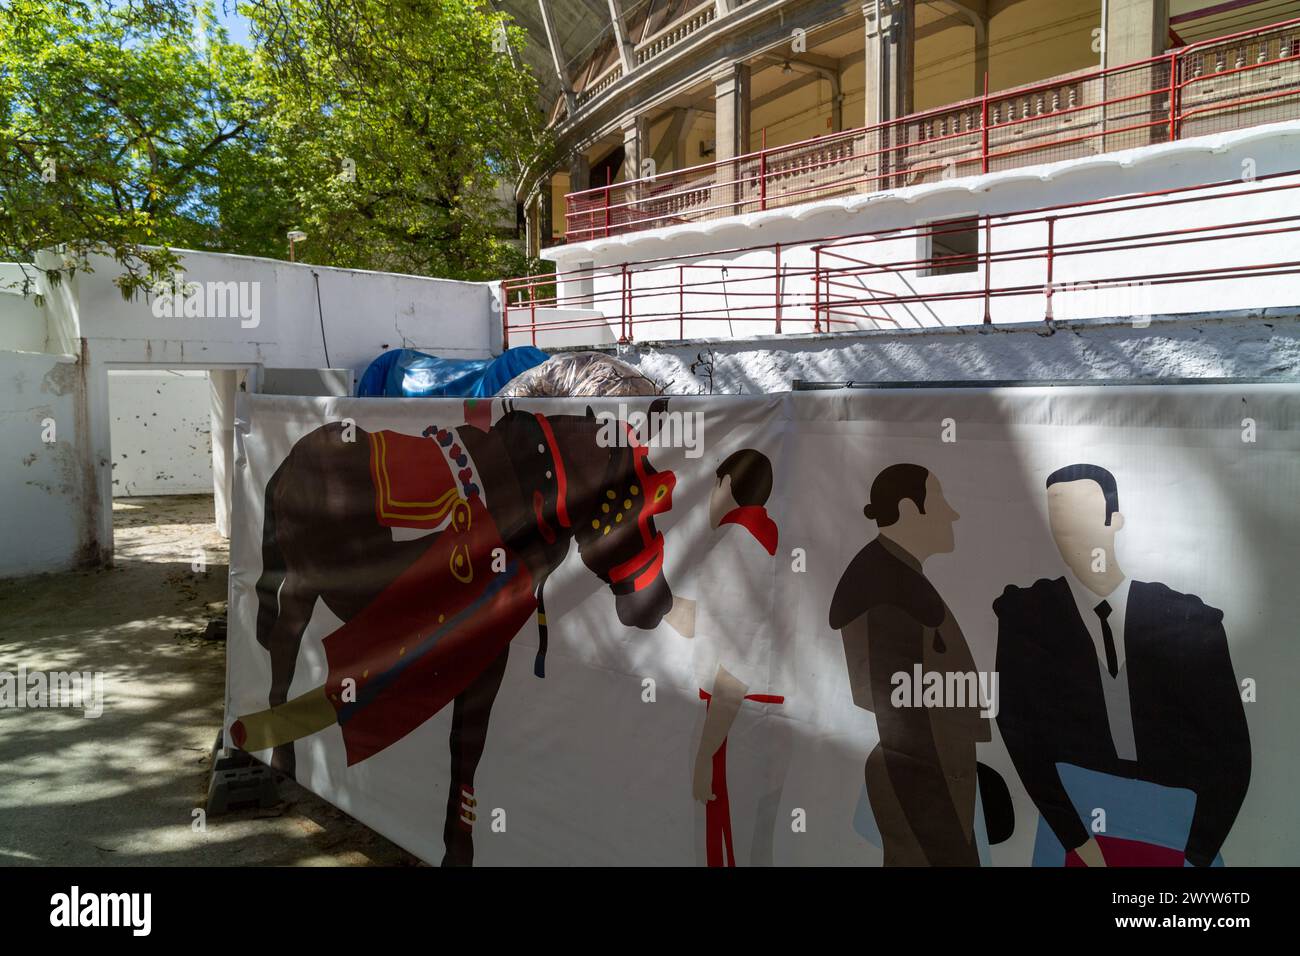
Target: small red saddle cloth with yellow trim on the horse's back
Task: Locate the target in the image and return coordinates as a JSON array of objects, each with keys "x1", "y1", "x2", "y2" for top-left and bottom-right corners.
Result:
[{"x1": 369, "y1": 431, "x2": 460, "y2": 528}]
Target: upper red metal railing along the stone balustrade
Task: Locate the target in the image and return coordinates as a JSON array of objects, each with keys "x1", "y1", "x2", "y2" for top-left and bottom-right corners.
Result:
[{"x1": 566, "y1": 18, "x2": 1300, "y2": 242}]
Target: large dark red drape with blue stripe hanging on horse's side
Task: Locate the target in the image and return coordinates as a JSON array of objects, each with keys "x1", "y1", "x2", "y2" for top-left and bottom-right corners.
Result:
[{"x1": 322, "y1": 497, "x2": 537, "y2": 766}]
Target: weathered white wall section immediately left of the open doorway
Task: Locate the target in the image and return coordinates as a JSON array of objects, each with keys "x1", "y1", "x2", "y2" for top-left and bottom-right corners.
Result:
[{"x1": 0, "y1": 351, "x2": 99, "y2": 576}]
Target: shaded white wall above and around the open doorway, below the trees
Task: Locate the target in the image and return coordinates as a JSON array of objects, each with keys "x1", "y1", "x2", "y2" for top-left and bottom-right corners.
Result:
[{"x1": 0, "y1": 251, "x2": 501, "y2": 574}]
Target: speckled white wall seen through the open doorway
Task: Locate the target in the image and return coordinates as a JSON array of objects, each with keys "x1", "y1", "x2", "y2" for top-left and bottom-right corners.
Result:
[{"x1": 108, "y1": 369, "x2": 212, "y2": 498}]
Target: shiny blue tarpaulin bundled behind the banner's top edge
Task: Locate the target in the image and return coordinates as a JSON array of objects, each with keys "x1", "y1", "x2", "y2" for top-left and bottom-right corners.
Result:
[{"x1": 356, "y1": 345, "x2": 550, "y2": 398}]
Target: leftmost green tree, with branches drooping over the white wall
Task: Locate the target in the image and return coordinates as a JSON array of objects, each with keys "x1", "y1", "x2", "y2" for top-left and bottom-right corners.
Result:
[{"x1": 0, "y1": 0, "x2": 269, "y2": 295}]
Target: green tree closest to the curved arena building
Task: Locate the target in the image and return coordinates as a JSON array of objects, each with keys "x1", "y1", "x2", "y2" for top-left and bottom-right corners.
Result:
[{"x1": 248, "y1": 0, "x2": 549, "y2": 278}]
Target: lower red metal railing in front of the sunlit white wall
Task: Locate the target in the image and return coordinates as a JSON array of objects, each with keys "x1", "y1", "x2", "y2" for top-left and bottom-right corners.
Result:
[{"x1": 502, "y1": 169, "x2": 1300, "y2": 346}]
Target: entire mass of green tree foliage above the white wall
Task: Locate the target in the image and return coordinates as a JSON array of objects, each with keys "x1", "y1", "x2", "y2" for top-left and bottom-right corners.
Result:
[{"x1": 0, "y1": 0, "x2": 547, "y2": 297}]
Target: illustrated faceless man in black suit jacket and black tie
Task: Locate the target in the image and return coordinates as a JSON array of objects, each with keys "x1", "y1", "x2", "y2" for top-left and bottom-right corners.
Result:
[{"x1": 993, "y1": 464, "x2": 1251, "y2": 866}]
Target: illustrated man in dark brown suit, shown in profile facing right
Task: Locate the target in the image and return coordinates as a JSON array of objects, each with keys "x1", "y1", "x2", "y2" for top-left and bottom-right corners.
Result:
[{"x1": 829, "y1": 464, "x2": 991, "y2": 866}]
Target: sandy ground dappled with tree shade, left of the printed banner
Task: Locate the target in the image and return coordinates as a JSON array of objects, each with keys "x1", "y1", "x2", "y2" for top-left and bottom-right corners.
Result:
[{"x1": 0, "y1": 496, "x2": 416, "y2": 866}]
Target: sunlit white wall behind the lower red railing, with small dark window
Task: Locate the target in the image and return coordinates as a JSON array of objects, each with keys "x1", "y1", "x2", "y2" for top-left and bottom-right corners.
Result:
[{"x1": 540, "y1": 121, "x2": 1300, "y2": 349}]
